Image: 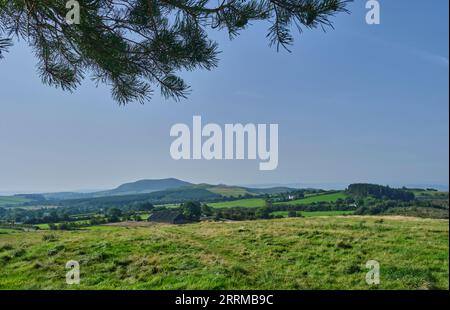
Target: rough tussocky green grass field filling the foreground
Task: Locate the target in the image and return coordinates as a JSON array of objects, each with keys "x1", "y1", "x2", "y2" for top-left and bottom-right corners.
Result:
[{"x1": 0, "y1": 216, "x2": 449, "y2": 289}]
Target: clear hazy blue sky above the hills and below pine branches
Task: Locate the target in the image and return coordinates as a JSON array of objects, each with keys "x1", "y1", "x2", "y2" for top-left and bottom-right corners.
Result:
[{"x1": 0, "y1": 0, "x2": 449, "y2": 192}]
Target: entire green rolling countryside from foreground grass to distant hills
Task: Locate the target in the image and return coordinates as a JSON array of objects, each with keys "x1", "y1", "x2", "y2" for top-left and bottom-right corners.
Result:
[{"x1": 0, "y1": 179, "x2": 449, "y2": 290}]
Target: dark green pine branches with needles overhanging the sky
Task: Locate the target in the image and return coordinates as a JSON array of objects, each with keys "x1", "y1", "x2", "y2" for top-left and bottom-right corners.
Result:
[{"x1": 0, "y1": 0, "x2": 350, "y2": 104}]
